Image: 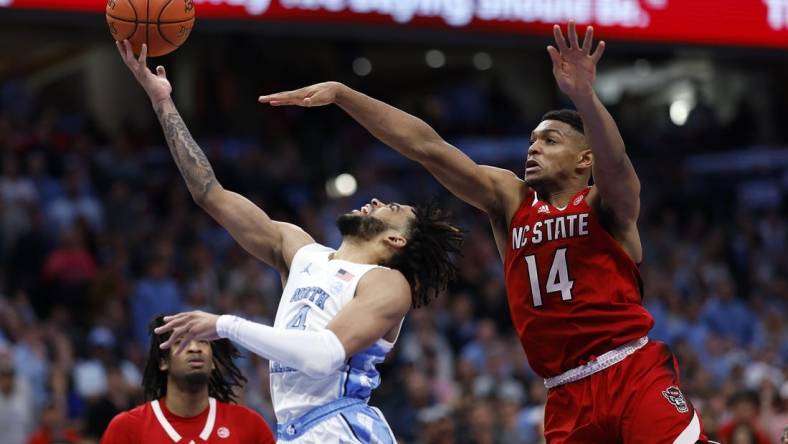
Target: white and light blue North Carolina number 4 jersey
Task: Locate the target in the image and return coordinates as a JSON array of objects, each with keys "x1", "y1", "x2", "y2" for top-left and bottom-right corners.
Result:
[{"x1": 270, "y1": 244, "x2": 394, "y2": 424}]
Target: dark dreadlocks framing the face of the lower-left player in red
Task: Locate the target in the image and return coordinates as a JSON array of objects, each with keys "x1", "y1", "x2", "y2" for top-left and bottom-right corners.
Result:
[{"x1": 142, "y1": 315, "x2": 246, "y2": 403}]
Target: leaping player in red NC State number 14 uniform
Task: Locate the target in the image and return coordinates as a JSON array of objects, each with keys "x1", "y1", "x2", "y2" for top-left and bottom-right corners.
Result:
[{"x1": 260, "y1": 22, "x2": 706, "y2": 444}]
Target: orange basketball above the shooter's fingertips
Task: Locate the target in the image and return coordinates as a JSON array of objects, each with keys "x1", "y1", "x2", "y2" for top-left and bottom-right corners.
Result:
[{"x1": 107, "y1": 0, "x2": 194, "y2": 57}]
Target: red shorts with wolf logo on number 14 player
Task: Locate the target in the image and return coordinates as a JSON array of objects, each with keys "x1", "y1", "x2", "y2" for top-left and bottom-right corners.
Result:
[{"x1": 545, "y1": 342, "x2": 707, "y2": 444}]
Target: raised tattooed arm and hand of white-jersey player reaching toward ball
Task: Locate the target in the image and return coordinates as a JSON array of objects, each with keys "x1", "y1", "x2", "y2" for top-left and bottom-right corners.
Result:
[{"x1": 117, "y1": 41, "x2": 314, "y2": 273}]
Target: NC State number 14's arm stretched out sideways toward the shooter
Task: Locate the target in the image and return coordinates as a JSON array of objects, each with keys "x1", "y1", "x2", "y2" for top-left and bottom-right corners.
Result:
[{"x1": 259, "y1": 82, "x2": 519, "y2": 214}]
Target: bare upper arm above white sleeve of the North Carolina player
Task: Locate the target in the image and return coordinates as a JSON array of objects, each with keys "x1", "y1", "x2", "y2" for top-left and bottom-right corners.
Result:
[{"x1": 326, "y1": 268, "x2": 412, "y2": 356}]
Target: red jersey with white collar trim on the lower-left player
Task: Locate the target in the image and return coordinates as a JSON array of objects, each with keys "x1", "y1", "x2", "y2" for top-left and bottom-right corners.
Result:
[{"x1": 101, "y1": 398, "x2": 274, "y2": 444}]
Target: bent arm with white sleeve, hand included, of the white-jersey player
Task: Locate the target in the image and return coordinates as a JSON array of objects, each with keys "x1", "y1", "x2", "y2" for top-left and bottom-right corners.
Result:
[{"x1": 156, "y1": 269, "x2": 412, "y2": 378}]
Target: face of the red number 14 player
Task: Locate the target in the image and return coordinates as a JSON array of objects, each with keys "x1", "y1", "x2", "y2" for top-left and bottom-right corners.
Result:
[{"x1": 525, "y1": 120, "x2": 585, "y2": 186}]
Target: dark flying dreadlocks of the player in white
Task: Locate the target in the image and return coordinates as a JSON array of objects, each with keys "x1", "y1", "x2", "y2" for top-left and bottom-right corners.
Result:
[{"x1": 381, "y1": 201, "x2": 464, "y2": 308}]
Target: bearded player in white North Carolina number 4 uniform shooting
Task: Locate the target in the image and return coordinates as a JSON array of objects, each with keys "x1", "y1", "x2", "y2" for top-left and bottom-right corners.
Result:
[{"x1": 118, "y1": 41, "x2": 462, "y2": 444}]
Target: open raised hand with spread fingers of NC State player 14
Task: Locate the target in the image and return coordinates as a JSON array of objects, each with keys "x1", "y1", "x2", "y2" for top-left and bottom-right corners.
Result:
[{"x1": 547, "y1": 21, "x2": 605, "y2": 98}]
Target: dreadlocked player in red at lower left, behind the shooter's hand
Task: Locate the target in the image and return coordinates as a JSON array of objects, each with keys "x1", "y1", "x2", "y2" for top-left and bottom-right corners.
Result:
[{"x1": 101, "y1": 316, "x2": 274, "y2": 444}]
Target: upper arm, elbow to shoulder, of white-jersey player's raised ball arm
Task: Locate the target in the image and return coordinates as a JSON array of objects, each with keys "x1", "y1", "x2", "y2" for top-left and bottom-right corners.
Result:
[{"x1": 200, "y1": 187, "x2": 314, "y2": 273}]
